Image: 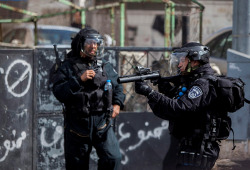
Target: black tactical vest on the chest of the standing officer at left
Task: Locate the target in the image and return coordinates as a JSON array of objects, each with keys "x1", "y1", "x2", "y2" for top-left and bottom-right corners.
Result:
[{"x1": 68, "y1": 59, "x2": 108, "y2": 115}]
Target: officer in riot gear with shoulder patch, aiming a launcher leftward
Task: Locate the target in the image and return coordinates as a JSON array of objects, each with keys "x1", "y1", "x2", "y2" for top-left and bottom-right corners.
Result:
[{"x1": 135, "y1": 42, "x2": 220, "y2": 170}]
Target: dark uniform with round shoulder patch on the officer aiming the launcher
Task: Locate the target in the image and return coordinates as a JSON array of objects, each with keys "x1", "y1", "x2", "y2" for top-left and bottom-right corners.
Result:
[{"x1": 148, "y1": 64, "x2": 220, "y2": 170}]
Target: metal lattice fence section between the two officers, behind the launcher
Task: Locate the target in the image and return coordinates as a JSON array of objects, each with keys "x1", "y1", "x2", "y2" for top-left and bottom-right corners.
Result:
[{"x1": 105, "y1": 47, "x2": 173, "y2": 112}]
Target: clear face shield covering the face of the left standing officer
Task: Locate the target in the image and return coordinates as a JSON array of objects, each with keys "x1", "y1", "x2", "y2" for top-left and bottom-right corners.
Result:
[{"x1": 81, "y1": 35, "x2": 104, "y2": 59}]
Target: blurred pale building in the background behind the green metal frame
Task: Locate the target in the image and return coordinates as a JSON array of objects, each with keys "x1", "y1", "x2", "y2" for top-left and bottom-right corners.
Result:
[{"x1": 0, "y1": 0, "x2": 233, "y2": 46}]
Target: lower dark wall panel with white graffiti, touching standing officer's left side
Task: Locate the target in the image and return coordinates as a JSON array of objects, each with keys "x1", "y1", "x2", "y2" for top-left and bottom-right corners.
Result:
[{"x1": 37, "y1": 116, "x2": 64, "y2": 170}]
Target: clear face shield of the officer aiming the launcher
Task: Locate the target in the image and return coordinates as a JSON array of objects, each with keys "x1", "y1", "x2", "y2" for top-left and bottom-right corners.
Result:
[{"x1": 169, "y1": 52, "x2": 188, "y2": 76}]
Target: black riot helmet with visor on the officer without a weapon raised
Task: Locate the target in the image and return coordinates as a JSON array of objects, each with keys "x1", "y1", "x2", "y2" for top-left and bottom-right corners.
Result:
[{"x1": 71, "y1": 27, "x2": 104, "y2": 59}]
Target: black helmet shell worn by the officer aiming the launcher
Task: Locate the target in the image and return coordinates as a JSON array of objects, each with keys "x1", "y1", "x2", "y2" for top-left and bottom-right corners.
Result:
[{"x1": 175, "y1": 42, "x2": 210, "y2": 64}]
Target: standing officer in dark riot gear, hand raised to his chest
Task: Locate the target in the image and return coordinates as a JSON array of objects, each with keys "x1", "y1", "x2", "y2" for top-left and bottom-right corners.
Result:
[{"x1": 53, "y1": 27, "x2": 125, "y2": 170}]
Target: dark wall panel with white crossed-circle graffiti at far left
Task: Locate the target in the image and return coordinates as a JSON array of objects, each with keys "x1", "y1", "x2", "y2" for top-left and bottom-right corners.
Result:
[{"x1": 0, "y1": 51, "x2": 33, "y2": 170}]
